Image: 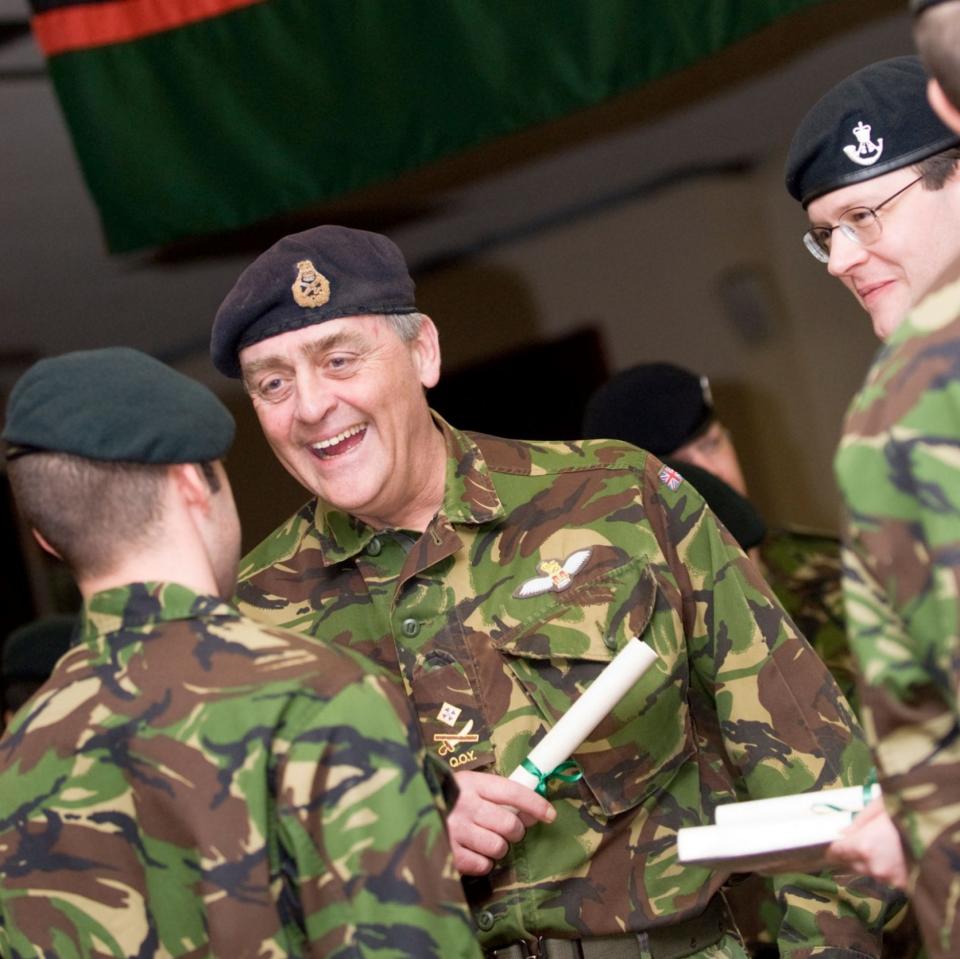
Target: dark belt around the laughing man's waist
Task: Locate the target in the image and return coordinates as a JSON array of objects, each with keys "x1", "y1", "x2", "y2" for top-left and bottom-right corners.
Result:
[{"x1": 484, "y1": 896, "x2": 739, "y2": 959}]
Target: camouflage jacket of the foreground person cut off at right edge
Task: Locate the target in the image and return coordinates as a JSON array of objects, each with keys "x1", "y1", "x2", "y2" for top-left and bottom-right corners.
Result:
[{"x1": 835, "y1": 282, "x2": 960, "y2": 959}]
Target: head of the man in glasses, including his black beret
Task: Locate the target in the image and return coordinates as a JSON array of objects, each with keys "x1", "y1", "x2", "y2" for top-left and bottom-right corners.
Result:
[{"x1": 786, "y1": 57, "x2": 960, "y2": 340}]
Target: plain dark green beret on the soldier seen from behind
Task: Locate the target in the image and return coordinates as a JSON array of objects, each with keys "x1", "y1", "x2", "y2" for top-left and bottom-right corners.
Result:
[{"x1": 3, "y1": 346, "x2": 234, "y2": 464}]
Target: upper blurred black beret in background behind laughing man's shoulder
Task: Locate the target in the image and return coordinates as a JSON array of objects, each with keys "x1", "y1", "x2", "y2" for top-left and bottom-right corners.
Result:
[{"x1": 583, "y1": 363, "x2": 714, "y2": 456}]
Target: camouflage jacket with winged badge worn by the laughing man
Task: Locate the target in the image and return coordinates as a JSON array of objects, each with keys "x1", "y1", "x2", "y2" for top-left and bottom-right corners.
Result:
[{"x1": 239, "y1": 417, "x2": 880, "y2": 957}]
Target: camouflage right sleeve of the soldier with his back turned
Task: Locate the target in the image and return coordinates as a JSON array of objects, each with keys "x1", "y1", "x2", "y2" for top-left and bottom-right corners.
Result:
[{"x1": 277, "y1": 676, "x2": 480, "y2": 959}]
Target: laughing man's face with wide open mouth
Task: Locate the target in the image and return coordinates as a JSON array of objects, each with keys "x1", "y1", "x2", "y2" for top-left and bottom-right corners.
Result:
[{"x1": 240, "y1": 316, "x2": 443, "y2": 528}]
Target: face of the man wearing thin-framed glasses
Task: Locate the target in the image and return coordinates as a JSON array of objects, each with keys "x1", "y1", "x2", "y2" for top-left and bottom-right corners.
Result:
[{"x1": 807, "y1": 166, "x2": 960, "y2": 340}]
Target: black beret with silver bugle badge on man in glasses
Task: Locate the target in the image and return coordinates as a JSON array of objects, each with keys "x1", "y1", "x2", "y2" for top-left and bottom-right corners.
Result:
[{"x1": 786, "y1": 56, "x2": 960, "y2": 207}]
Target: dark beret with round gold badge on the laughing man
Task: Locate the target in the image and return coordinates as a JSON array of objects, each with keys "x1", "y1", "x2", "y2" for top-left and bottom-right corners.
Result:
[{"x1": 210, "y1": 226, "x2": 417, "y2": 377}]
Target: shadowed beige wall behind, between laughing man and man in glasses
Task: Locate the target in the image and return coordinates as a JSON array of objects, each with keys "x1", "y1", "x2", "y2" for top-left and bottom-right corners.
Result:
[{"x1": 418, "y1": 156, "x2": 877, "y2": 528}]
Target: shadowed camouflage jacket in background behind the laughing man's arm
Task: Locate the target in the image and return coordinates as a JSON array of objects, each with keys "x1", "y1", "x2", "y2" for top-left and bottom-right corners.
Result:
[{"x1": 759, "y1": 527, "x2": 859, "y2": 713}]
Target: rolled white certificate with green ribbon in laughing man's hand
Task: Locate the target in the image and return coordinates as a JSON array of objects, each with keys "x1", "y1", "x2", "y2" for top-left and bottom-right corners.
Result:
[{"x1": 510, "y1": 637, "x2": 657, "y2": 794}]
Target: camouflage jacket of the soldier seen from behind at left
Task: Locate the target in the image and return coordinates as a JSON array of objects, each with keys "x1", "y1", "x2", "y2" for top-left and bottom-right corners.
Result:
[{"x1": 0, "y1": 584, "x2": 479, "y2": 959}]
